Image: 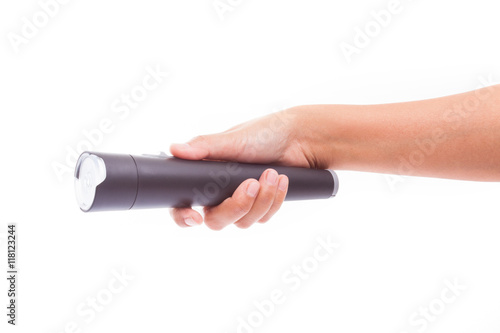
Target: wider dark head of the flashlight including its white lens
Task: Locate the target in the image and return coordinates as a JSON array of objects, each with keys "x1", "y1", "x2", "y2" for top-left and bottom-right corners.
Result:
[{"x1": 75, "y1": 152, "x2": 137, "y2": 212}]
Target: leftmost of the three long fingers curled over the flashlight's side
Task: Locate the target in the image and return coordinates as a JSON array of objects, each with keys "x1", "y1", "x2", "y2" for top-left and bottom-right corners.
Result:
[{"x1": 205, "y1": 179, "x2": 260, "y2": 230}]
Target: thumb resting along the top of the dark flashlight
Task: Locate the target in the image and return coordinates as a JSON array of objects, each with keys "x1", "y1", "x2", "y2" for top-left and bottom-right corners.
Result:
[{"x1": 170, "y1": 134, "x2": 236, "y2": 160}]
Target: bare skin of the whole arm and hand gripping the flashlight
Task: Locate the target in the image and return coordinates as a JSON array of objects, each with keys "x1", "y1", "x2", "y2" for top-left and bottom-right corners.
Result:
[{"x1": 170, "y1": 85, "x2": 500, "y2": 230}]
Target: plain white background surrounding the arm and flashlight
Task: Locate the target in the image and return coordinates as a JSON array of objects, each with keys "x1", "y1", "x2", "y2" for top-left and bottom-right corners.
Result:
[{"x1": 0, "y1": 0, "x2": 500, "y2": 333}]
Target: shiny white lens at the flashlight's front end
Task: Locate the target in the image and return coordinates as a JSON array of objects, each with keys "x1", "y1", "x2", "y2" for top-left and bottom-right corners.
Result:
[{"x1": 75, "y1": 153, "x2": 106, "y2": 211}]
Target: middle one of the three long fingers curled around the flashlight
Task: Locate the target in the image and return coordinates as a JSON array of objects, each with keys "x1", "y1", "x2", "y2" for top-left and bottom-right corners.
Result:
[{"x1": 235, "y1": 169, "x2": 279, "y2": 228}]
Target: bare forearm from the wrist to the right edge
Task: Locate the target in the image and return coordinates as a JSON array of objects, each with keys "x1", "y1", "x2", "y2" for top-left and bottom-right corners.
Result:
[{"x1": 293, "y1": 85, "x2": 500, "y2": 181}]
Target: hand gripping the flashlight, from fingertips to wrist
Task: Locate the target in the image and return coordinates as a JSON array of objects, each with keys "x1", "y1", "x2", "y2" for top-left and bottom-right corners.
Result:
[{"x1": 170, "y1": 110, "x2": 313, "y2": 230}]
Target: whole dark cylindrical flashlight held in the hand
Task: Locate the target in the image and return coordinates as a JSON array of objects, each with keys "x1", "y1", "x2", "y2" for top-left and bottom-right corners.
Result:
[{"x1": 75, "y1": 152, "x2": 339, "y2": 212}]
